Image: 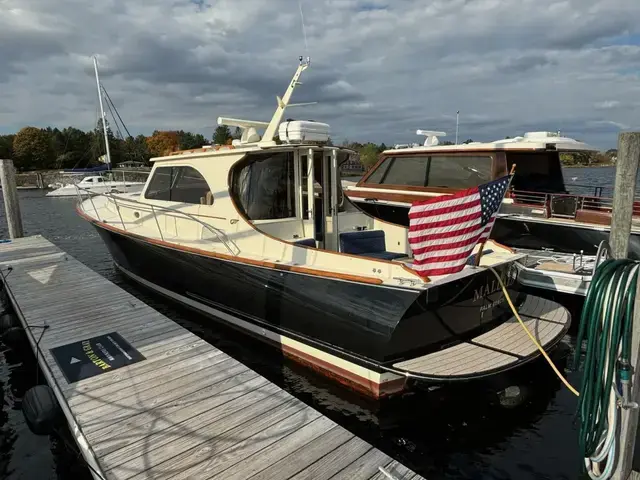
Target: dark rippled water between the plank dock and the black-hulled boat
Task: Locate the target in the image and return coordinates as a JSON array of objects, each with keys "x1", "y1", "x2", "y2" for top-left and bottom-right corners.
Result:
[{"x1": 0, "y1": 188, "x2": 584, "y2": 480}]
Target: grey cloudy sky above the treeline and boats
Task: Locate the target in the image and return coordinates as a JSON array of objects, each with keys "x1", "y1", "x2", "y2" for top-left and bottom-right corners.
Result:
[{"x1": 0, "y1": 0, "x2": 640, "y2": 148}]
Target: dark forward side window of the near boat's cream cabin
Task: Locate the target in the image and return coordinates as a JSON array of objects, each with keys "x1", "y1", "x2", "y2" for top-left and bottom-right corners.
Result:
[{"x1": 144, "y1": 166, "x2": 211, "y2": 204}]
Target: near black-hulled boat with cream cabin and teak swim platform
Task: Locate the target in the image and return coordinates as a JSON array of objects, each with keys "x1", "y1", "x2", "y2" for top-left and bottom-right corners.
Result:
[{"x1": 78, "y1": 62, "x2": 570, "y2": 397}]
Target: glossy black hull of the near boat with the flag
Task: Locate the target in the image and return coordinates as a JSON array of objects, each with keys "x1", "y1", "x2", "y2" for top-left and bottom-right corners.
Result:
[{"x1": 94, "y1": 223, "x2": 523, "y2": 398}]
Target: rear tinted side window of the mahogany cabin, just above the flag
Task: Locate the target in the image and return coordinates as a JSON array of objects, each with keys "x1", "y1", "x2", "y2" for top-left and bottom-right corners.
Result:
[{"x1": 427, "y1": 156, "x2": 491, "y2": 188}]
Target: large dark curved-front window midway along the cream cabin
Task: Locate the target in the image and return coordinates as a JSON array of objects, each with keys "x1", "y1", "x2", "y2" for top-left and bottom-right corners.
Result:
[{"x1": 232, "y1": 152, "x2": 296, "y2": 220}]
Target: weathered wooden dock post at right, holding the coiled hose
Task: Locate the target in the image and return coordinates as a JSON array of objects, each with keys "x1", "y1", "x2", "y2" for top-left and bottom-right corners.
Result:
[{"x1": 609, "y1": 132, "x2": 640, "y2": 480}]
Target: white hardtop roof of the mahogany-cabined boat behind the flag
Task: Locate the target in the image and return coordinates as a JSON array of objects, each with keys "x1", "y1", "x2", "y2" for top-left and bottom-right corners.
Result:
[{"x1": 383, "y1": 130, "x2": 598, "y2": 154}]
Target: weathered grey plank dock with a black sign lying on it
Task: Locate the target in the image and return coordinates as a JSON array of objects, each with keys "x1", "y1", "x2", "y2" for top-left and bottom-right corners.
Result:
[{"x1": 0, "y1": 236, "x2": 422, "y2": 480}]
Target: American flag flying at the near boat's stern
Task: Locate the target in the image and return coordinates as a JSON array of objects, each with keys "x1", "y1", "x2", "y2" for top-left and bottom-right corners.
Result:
[{"x1": 409, "y1": 175, "x2": 512, "y2": 277}]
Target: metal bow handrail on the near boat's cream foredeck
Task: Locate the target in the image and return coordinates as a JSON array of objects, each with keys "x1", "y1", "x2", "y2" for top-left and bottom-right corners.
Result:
[{"x1": 76, "y1": 184, "x2": 240, "y2": 256}]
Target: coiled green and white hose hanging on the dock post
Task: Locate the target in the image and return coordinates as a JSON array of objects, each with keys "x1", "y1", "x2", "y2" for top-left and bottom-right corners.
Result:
[{"x1": 574, "y1": 260, "x2": 640, "y2": 480}]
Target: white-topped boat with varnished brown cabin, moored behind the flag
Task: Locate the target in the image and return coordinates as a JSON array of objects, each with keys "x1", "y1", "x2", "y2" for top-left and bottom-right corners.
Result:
[{"x1": 345, "y1": 130, "x2": 640, "y2": 259}]
